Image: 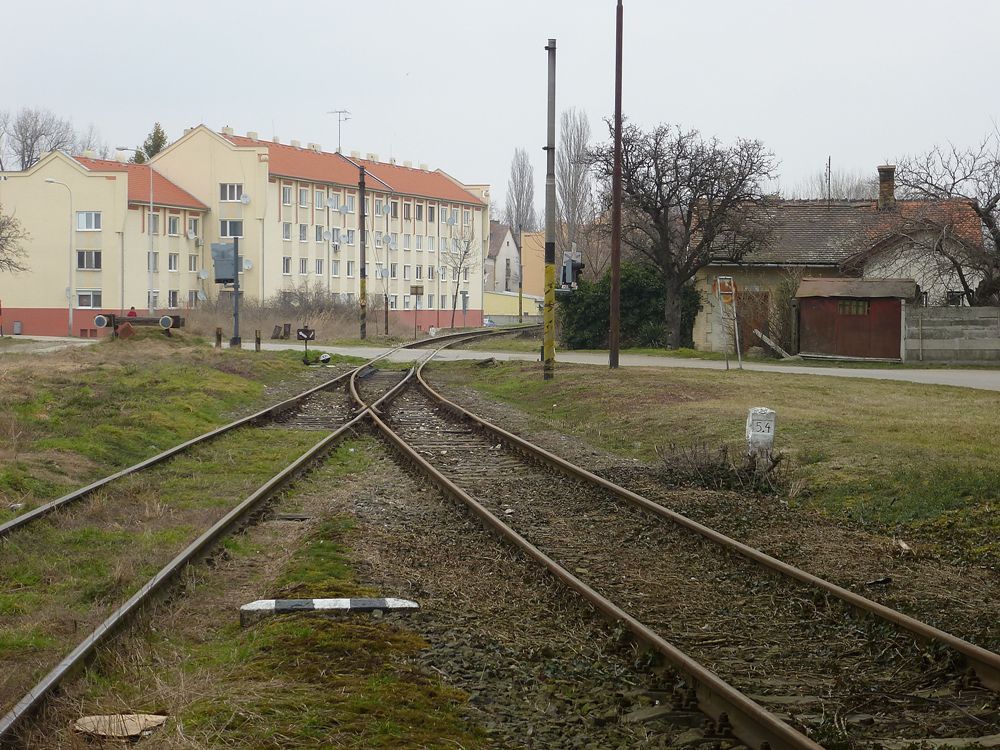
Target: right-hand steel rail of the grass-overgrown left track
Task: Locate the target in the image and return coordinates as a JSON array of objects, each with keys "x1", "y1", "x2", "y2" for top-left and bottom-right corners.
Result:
[{"x1": 0, "y1": 366, "x2": 414, "y2": 746}]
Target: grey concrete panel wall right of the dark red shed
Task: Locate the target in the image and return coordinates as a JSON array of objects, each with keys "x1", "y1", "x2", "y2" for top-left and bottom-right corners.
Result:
[{"x1": 905, "y1": 305, "x2": 1000, "y2": 362}]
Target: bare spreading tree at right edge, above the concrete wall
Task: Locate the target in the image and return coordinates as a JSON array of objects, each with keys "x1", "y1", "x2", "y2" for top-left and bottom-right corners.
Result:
[{"x1": 896, "y1": 138, "x2": 1000, "y2": 305}]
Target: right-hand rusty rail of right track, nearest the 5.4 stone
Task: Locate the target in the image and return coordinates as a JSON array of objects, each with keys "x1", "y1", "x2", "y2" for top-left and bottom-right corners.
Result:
[{"x1": 416, "y1": 358, "x2": 1000, "y2": 691}]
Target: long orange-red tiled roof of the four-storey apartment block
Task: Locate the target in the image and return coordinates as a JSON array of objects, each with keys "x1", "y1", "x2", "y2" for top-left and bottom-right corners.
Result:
[{"x1": 223, "y1": 135, "x2": 483, "y2": 206}]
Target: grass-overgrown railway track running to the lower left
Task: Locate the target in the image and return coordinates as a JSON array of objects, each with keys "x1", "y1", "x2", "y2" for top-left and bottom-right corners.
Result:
[{"x1": 0, "y1": 330, "x2": 536, "y2": 745}]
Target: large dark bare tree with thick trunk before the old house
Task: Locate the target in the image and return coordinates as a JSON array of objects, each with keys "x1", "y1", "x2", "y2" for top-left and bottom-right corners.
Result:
[{"x1": 594, "y1": 123, "x2": 775, "y2": 348}]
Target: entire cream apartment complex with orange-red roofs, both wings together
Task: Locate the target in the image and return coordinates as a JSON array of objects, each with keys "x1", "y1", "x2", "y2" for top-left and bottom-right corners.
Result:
[{"x1": 0, "y1": 125, "x2": 489, "y2": 335}]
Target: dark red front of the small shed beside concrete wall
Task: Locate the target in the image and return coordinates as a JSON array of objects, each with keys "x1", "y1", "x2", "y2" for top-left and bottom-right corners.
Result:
[{"x1": 799, "y1": 297, "x2": 901, "y2": 359}]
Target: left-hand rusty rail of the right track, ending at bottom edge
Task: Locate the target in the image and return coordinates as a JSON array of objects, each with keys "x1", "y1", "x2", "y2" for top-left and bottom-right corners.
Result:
[{"x1": 362, "y1": 347, "x2": 822, "y2": 750}]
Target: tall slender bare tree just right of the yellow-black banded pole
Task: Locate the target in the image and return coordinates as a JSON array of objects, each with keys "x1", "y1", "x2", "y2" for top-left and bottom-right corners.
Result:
[{"x1": 556, "y1": 107, "x2": 594, "y2": 252}]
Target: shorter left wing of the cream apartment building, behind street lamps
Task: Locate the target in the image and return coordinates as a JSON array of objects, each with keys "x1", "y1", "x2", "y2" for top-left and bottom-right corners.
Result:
[{"x1": 0, "y1": 151, "x2": 212, "y2": 337}]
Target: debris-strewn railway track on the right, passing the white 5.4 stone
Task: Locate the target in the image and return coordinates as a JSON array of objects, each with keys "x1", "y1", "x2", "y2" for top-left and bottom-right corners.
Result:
[{"x1": 359, "y1": 348, "x2": 1000, "y2": 748}]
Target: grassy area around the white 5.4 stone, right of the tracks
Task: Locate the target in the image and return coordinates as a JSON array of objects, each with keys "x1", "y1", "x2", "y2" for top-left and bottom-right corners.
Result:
[{"x1": 431, "y1": 362, "x2": 1000, "y2": 565}]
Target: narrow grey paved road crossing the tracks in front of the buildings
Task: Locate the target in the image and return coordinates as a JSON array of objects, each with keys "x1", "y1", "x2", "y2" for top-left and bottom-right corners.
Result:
[{"x1": 258, "y1": 342, "x2": 1000, "y2": 391}]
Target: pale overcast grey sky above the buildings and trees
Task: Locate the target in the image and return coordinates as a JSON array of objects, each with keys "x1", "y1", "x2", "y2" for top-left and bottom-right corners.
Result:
[{"x1": 0, "y1": 0, "x2": 1000, "y2": 208}]
